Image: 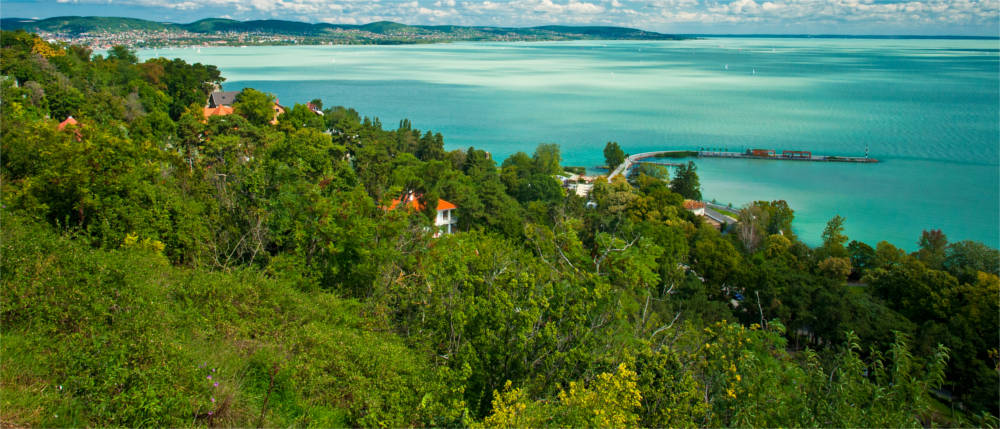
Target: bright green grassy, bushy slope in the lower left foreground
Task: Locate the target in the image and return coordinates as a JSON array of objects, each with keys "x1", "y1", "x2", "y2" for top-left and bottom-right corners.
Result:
[{"x1": 0, "y1": 219, "x2": 459, "y2": 427}]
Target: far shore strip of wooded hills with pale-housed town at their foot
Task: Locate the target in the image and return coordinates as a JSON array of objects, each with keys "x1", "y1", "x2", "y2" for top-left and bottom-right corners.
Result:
[{"x1": 0, "y1": 17, "x2": 679, "y2": 49}]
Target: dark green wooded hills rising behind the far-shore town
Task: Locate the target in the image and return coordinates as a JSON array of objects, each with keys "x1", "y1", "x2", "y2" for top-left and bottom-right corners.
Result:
[{"x1": 0, "y1": 16, "x2": 681, "y2": 40}]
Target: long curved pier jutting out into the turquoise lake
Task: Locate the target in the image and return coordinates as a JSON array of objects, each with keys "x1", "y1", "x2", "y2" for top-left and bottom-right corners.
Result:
[{"x1": 608, "y1": 149, "x2": 878, "y2": 183}]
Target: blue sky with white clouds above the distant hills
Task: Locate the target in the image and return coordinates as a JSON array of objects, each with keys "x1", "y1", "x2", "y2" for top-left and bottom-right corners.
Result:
[{"x1": 0, "y1": 0, "x2": 1000, "y2": 37}]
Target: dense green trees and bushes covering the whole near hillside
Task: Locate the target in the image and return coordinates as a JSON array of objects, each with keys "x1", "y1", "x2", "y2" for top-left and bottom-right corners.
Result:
[{"x1": 0, "y1": 32, "x2": 1000, "y2": 427}]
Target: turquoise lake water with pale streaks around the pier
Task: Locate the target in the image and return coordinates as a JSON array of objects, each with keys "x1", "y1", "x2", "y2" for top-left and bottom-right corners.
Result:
[{"x1": 140, "y1": 38, "x2": 1000, "y2": 250}]
